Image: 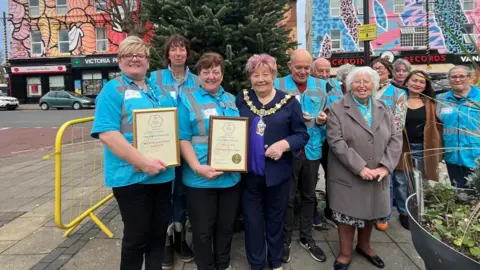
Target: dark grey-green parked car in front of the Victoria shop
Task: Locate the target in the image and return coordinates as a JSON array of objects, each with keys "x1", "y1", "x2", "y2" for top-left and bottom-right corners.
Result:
[{"x1": 38, "y1": 90, "x2": 95, "y2": 111}]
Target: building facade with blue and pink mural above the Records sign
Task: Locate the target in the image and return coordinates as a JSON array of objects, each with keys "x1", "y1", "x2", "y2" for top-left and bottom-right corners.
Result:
[{"x1": 306, "y1": 0, "x2": 480, "y2": 72}]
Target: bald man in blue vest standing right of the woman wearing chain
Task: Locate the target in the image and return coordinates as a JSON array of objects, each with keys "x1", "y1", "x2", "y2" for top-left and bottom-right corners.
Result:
[{"x1": 274, "y1": 49, "x2": 328, "y2": 263}]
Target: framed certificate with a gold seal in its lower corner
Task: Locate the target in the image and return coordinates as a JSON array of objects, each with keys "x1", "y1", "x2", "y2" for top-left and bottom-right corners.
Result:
[{"x1": 207, "y1": 116, "x2": 249, "y2": 173}]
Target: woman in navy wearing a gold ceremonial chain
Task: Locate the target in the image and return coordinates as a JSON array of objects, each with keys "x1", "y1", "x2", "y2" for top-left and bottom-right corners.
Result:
[{"x1": 236, "y1": 54, "x2": 309, "y2": 270}]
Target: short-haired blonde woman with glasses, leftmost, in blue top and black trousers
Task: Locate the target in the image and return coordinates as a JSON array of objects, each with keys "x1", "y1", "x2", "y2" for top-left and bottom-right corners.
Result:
[{"x1": 91, "y1": 36, "x2": 176, "y2": 270}]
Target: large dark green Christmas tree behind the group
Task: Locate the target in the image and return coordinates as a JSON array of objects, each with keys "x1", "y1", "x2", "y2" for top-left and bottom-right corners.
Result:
[{"x1": 141, "y1": 0, "x2": 296, "y2": 94}]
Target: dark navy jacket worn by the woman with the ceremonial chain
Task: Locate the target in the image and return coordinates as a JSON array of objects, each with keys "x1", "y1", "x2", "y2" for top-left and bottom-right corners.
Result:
[{"x1": 236, "y1": 90, "x2": 309, "y2": 186}]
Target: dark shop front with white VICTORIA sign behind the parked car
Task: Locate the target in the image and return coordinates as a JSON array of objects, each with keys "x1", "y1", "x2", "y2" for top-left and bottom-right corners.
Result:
[{"x1": 71, "y1": 55, "x2": 120, "y2": 98}]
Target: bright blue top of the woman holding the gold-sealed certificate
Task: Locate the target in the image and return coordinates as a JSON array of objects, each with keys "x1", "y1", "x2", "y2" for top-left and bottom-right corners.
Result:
[{"x1": 178, "y1": 87, "x2": 240, "y2": 188}]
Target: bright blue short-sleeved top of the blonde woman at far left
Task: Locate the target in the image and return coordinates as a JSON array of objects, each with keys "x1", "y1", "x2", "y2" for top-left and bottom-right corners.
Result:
[{"x1": 91, "y1": 73, "x2": 175, "y2": 187}]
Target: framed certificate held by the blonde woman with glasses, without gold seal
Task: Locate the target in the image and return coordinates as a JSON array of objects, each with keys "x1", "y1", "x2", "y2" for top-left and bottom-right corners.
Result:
[{"x1": 132, "y1": 107, "x2": 181, "y2": 167}]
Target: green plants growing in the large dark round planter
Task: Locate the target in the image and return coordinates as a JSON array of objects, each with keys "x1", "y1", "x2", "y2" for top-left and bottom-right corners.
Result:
[{"x1": 423, "y1": 182, "x2": 480, "y2": 261}]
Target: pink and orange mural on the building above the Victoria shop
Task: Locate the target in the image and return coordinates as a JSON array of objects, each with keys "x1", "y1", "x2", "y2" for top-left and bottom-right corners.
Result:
[{"x1": 9, "y1": 0, "x2": 135, "y2": 59}]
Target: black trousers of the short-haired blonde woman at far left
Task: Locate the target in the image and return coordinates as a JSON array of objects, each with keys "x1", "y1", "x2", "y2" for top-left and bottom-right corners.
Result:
[{"x1": 113, "y1": 182, "x2": 172, "y2": 270}]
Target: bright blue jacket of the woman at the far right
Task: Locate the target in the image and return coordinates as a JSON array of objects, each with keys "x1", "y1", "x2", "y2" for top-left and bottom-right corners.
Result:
[{"x1": 437, "y1": 86, "x2": 480, "y2": 168}]
